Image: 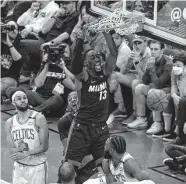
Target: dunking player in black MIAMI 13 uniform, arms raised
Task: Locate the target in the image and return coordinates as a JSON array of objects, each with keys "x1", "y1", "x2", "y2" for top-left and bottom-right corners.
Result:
[{"x1": 63, "y1": 27, "x2": 117, "y2": 183}]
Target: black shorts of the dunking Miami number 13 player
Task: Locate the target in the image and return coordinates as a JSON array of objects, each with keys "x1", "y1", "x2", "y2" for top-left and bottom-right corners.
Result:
[{"x1": 66, "y1": 122, "x2": 109, "y2": 166}]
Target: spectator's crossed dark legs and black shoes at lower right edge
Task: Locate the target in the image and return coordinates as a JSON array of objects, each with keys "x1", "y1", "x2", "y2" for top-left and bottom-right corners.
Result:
[{"x1": 163, "y1": 145, "x2": 186, "y2": 174}]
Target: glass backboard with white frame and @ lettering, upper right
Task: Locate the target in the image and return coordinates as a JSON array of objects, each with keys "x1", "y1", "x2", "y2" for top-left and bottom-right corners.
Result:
[{"x1": 87, "y1": 0, "x2": 186, "y2": 50}]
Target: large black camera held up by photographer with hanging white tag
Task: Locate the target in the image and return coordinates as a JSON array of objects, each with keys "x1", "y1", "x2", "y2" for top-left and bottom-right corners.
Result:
[{"x1": 43, "y1": 43, "x2": 66, "y2": 64}]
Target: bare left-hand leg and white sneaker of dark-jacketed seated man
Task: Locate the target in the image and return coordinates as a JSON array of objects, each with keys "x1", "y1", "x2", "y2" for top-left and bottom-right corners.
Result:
[{"x1": 127, "y1": 84, "x2": 150, "y2": 128}]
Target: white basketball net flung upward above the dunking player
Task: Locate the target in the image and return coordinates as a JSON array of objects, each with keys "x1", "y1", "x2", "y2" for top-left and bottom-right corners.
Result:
[{"x1": 85, "y1": 9, "x2": 144, "y2": 35}]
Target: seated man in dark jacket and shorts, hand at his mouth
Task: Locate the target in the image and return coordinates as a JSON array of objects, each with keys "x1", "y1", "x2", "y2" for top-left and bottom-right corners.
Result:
[{"x1": 128, "y1": 40, "x2": 172, "y2": 134}]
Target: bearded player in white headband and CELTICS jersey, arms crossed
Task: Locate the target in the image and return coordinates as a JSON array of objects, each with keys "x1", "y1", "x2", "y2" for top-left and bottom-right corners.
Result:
[{"x1": 6, "y1": 89, "x2": 48, "y2": 184}]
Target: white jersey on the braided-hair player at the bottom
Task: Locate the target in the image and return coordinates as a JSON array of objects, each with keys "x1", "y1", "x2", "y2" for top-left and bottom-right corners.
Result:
[{"x1": 109, "y1": 152, "x2": 138, "y2": 182}]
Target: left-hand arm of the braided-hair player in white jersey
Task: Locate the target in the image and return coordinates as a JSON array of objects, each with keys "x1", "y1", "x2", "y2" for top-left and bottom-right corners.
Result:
[{"x1": 102, "y1": 159, "x2": 115, "y2": 184}]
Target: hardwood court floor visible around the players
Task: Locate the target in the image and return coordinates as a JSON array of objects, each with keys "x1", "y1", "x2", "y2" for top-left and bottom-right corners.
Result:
[{"x1": 1, "y1": 105, "x2": 186, "y2": 184}]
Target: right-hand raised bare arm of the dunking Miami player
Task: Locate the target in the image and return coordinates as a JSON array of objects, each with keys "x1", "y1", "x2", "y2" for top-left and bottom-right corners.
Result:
[{"x1": 103, "y1": 33, "x2": 118, "y2": 75}]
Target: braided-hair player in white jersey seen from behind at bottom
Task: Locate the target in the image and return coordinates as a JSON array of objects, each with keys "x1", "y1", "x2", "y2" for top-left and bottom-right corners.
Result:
[{"x1": 84, "y1": 135, "x2": 154, "y2": 184}]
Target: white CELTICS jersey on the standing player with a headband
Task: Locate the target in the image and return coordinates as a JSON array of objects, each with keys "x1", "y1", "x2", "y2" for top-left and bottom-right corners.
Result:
[{"x1": 11, "y1": 110, "x2": 47, "y2": 166}]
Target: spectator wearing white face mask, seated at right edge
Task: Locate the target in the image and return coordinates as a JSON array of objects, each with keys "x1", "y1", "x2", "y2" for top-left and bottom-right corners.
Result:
[{"x1": 161, "y1": 54, "x2": 186, "y2": 144}]
